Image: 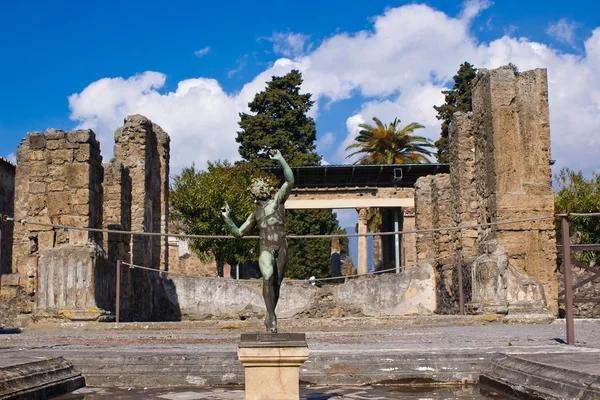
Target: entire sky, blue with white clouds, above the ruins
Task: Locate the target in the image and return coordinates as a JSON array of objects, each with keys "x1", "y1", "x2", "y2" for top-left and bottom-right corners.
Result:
[{"x1": 0, "y1": 0, "x2": 600, "y2": 268}]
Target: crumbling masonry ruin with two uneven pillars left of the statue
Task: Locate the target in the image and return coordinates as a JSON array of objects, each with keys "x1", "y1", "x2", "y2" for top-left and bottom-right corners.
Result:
[{"x1": 3, "y1": 115, "x2": 169, "y2": 319}]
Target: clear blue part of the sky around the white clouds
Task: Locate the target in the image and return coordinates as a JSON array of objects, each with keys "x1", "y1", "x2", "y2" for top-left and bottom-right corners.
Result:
[{"x1": 0, "y1": 0, "x2": 600, "y2": 168}]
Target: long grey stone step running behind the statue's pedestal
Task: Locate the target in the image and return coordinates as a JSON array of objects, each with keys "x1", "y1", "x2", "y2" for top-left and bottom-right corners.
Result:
[{"x1": 58, "y1": 350, "x2": 493, "y2": 387}]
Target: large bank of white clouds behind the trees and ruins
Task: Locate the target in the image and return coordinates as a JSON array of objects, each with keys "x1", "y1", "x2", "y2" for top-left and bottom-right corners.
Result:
[{"x1": 69, "y1": 1, "x2": 600, "y2": 177}]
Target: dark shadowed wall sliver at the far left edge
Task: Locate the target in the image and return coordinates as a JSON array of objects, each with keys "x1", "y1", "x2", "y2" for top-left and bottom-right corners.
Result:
[{"x1": 0, "y1": 158, "x2": 16, "y2": 274}]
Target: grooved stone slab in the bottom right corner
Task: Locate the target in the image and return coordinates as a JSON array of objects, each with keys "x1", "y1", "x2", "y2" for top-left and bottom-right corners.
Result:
[{"x1": 479, "y1": 352, "x2": 600, "y2": 400}]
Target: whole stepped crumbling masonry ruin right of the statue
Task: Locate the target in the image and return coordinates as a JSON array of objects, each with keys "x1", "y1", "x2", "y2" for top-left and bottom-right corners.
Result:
[{"x1": 415, "y1": 67, "x2": 558, "y2": 315}]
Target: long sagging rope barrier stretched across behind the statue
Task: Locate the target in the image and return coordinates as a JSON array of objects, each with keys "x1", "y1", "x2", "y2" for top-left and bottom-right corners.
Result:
[{"x1": 3, "y1": 213, "x2": 556, "y2": 239}]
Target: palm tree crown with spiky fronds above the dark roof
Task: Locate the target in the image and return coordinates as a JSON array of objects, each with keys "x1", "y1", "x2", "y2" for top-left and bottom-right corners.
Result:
[{"x1": 346, "y1": 118, "x2": 433, "y2": 165}]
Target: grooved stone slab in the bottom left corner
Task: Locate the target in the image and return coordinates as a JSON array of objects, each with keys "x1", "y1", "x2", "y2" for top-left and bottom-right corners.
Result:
[{"x1": 0, "y1": 354, "x2": 85, "y2": 400}]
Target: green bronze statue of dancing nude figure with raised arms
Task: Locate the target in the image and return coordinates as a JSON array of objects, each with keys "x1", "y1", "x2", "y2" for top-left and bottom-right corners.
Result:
[{"x1": 222, "y1": 150, "x2": 294, "y2": 333}]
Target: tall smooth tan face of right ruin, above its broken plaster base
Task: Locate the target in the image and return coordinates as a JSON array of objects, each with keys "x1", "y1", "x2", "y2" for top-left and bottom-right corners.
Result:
[{"x1": 473, "y1": 67, "x2": 558, "y2": 313}]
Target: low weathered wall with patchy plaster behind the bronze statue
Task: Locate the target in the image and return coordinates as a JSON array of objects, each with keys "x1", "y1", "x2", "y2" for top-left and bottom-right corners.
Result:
[{"x1": 155, "y1": 265, "x2": 436, "y2": 320}]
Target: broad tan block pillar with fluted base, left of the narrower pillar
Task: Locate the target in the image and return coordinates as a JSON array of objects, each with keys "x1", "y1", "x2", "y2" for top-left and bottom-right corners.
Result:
[{"x1": 12, "y1": 129, "x2": 108, "y2": 314}]
